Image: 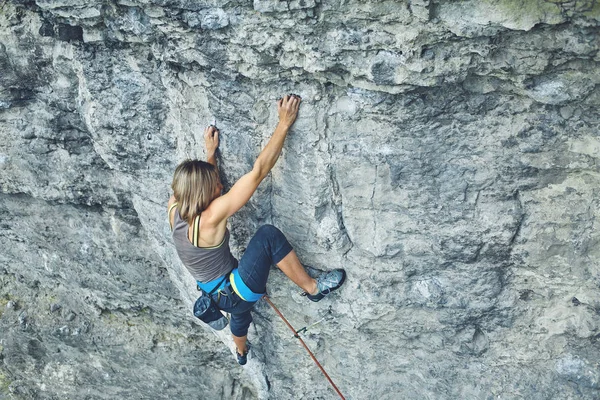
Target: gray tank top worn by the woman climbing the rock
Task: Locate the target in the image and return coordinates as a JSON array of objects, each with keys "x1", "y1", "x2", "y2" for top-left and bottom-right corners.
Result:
[{"x1": 173, "y1": 208, "x2": 238, "y2": 283}]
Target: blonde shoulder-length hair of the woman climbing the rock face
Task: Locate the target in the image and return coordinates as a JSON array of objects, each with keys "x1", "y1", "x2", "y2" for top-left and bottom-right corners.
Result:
[{"x1": 171, "y1": 160, "x2": 219, "y2": 224}]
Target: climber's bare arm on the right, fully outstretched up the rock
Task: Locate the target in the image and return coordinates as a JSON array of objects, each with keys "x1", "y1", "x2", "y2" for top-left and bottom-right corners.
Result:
[{"x1": 207, "y1": 95, "x2": 301, "y2": 225}]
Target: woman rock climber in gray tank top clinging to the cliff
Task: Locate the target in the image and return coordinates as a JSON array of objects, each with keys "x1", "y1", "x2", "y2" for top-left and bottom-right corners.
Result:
[{"x1": 168, "y1": 95, "x2": 346, "y2": 365}]
